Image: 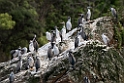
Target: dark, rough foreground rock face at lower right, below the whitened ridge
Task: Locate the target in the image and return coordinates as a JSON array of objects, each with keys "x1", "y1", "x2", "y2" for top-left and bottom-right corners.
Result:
[{"x1": 43, "y1": 41, "x2": 124, "y2": 83}]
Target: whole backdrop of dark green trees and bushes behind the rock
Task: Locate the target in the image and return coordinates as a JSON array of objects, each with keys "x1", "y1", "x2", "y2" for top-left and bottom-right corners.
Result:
[{"x1": 0, "y1": 0, "x2": 124, "y2": 61}]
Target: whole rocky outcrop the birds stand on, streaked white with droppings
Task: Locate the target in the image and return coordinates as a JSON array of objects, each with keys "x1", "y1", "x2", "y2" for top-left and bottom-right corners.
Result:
[{"x1": 0, "y1": 17, "x2": 124, "y2": 83}]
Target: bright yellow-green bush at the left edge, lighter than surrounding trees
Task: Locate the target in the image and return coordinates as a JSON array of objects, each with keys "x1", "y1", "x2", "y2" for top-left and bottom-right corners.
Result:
[{"x1": 0, "y1": 13, "x2": 16, "y2": 29}]
